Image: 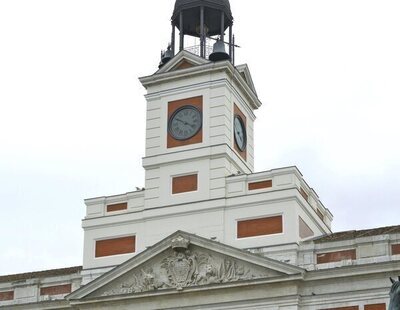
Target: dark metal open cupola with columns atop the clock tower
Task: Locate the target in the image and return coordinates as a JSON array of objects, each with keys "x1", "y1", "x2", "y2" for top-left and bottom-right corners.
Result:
[{"x1": 164, "y1": 0, "x2": 234, "y2": 61}]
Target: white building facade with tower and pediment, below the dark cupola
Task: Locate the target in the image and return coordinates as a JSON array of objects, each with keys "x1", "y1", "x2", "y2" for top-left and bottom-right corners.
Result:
[{"x1": 0, "y1": 3, "x2": 400, "y2": 310}]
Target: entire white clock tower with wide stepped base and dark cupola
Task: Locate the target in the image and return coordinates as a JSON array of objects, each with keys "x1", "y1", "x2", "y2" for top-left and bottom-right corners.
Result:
[{"x1": 83, "y1": 0, "x2": 332, "y2": 281}]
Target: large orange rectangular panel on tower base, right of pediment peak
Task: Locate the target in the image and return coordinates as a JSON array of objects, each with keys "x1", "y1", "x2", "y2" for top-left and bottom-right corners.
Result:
[{"x1": 237, "y1": 215, "x2": 283, "y2": 238}]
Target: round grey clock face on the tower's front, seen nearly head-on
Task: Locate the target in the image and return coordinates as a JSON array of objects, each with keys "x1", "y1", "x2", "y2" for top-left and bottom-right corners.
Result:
[{"x1": 168, "y1": 105, "x2": 202, "y2": 140}]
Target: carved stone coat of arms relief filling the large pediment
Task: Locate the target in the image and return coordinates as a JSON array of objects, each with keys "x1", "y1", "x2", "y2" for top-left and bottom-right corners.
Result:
[{"x1": 102, "y1": 236, "x2": 271, "y2": 296}]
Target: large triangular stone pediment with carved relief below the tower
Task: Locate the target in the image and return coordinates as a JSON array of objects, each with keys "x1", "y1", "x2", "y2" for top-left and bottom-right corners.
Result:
[{"x1": 67, "y1": 231, "x2": 304, "y2": 300}]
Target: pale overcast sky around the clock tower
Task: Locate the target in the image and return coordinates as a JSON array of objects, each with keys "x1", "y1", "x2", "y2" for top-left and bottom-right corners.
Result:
[{"x1": 0, "y1": 0, "x2": 400, "y2": 274}]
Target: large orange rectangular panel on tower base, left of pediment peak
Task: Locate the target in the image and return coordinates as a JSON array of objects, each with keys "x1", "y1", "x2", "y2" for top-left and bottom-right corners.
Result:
[{"x1": 96, "y1": 236, "x2": 136, "y2": 257}]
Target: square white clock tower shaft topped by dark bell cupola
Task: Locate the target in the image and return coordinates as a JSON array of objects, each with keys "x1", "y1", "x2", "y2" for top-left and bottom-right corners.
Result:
[{"x1": 140, "y1": 0, "x2": 261, "y2": 208}]
